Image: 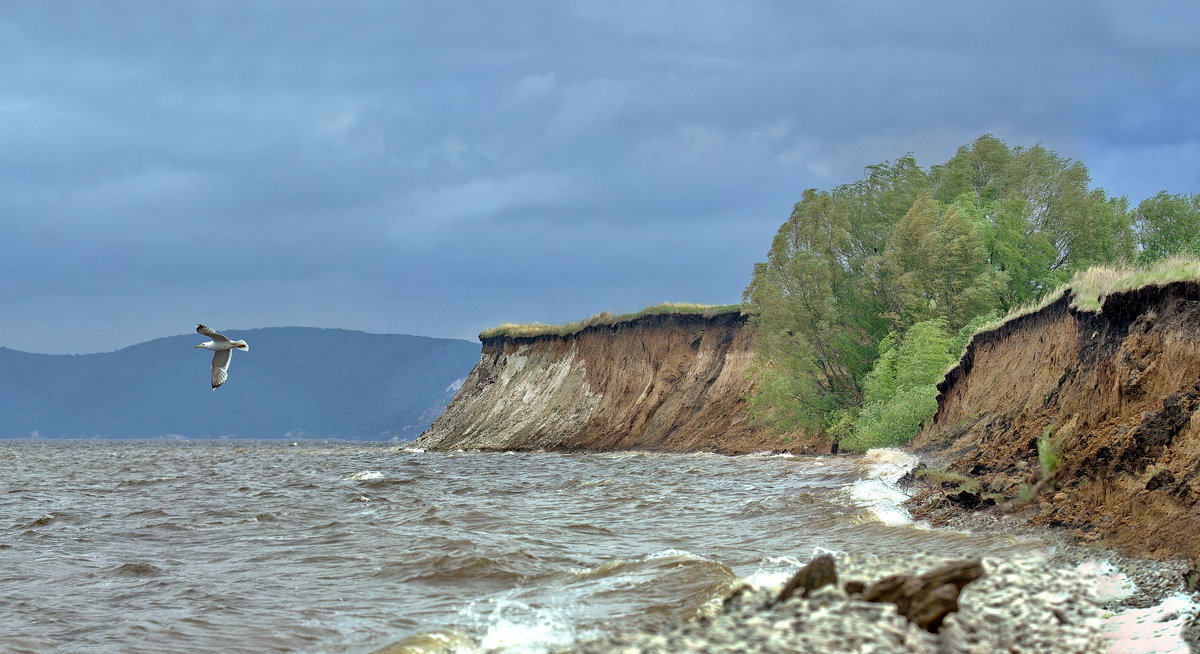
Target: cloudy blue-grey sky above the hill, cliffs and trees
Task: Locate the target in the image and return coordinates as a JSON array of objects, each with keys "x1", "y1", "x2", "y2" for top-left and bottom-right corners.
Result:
[{"x1": 0, "y1": 0, "x2": 1200, "y2": 353}]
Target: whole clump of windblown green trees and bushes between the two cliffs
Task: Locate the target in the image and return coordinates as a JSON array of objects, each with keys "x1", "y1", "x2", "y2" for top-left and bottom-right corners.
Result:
[{"x1": 743, "y1": 136, "x2": 1200, "y2": 449}]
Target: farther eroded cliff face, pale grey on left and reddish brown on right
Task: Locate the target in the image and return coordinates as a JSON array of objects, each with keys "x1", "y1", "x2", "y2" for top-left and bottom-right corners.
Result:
[{"x1": 414, "y1": 312, "x2": 806, "y2": 454}]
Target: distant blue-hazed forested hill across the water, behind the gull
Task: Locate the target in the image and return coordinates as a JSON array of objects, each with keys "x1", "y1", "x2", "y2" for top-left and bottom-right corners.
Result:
[{"x1": 0, "y1": 328, "x2": 479, "y2": 440}]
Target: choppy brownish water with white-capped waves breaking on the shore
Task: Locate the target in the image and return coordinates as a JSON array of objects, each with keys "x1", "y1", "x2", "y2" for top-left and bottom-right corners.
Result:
[{"x1": 0, "y1": 442, "x2": 1041, "y2": 653}]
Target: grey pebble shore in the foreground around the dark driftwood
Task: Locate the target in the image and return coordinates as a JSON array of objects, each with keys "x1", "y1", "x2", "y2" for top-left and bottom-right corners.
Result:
[{"x1": 566, "y1": 544, "x2": 1198, "y2": 654}]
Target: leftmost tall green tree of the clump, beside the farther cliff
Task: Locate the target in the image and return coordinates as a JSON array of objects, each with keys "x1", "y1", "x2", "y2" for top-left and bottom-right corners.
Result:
[{"x1": 743, "y1": 156, "x2": 928, "y2": 431}]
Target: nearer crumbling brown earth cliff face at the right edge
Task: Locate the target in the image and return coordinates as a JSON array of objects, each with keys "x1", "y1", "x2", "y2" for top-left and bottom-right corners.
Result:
[{"x1": 911, "y1": 282, "x2": 1200, "y2": 558}]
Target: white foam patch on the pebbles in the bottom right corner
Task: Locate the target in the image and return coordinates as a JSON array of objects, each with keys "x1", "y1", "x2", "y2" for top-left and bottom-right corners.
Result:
[{"x1": 1102, "y1": 593, "x2": 1200, "y2": 654}]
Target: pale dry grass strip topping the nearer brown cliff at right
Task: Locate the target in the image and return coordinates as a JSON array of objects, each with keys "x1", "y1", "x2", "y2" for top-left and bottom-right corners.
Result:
[{"x1": 976, "y1": 257, "x2": 1200, "y2": 334}]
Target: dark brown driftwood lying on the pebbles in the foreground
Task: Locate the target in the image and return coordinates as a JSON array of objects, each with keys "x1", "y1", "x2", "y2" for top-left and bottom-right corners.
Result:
[{"x1": 767, "y1": 554, "x2": 983, "y2": 634}]
